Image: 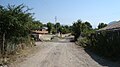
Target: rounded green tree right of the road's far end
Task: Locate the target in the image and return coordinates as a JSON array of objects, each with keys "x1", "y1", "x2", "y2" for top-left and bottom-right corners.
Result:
[{"x1": 72, "y1": 20, "x2": 92, "y2": 40}]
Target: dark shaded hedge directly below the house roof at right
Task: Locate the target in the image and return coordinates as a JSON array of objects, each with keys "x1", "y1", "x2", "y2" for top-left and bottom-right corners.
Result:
[{"x1": 90, "y1": 30, "x2": 120, "y2": 58}]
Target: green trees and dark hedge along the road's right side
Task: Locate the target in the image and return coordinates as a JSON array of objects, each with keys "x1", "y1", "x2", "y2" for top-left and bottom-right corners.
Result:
[{"x1": 72, "y1": 20, "x2": 120, "y2": 60}]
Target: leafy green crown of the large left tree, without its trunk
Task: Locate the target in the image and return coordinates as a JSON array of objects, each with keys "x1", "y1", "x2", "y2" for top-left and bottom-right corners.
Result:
[{"x1": 0, "y1": 5, "x2": 32, "y2": 39}]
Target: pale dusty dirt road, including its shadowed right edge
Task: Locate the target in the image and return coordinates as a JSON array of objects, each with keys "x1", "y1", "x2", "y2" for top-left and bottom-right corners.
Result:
[{"x1": 10, "y1": 40, "x2": 119, "y2": 67}]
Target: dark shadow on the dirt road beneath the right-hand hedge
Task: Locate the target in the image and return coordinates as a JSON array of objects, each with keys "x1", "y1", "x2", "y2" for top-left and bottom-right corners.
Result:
[{"x1": 85, "y1": 48, "x2": 120, "y2": 67}]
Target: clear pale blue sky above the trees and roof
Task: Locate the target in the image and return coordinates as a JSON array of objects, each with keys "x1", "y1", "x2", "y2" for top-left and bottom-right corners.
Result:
[{"x1": 0, "y1": 0, "x2": 120, "y2": 28}]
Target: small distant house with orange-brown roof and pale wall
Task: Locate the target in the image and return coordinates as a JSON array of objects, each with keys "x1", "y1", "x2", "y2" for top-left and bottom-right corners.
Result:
[{"x1": 32, "y1": 27, "x2": 48, "y2": 41}]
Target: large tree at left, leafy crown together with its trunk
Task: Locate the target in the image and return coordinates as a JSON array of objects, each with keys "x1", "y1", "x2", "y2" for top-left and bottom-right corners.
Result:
[{"x1": 0, "y1": 4, "x2": 33, "y2": 55}]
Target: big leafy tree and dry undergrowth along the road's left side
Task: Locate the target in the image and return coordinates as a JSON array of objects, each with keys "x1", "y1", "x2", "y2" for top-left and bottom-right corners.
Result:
[{"x1": 0, "y1": 4, "x2": 38, "y2": 64}]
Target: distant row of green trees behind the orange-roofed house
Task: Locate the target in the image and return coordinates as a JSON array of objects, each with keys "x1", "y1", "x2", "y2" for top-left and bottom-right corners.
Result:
[{"x1": 32, "y1": 21, "x2": 71, "y2": 34}]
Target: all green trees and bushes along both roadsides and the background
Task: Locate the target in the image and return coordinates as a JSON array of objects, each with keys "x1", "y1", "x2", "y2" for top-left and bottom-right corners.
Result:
[{"x1": 0, "y1": 4, "x2": 120, "y2": 65}]
